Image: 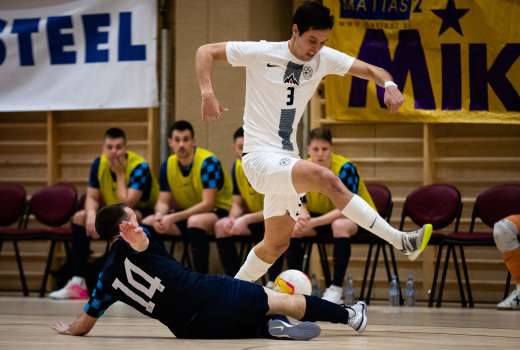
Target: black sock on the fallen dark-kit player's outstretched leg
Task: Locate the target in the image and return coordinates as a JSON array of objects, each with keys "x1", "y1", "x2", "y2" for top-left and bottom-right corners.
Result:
[{"x1": 300, "y1": 295, "x2": 349, "y2": 324}]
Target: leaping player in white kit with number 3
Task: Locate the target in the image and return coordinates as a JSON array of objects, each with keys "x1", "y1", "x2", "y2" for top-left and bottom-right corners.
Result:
[{"x1": 195, "y1": 2, "x2": 432, "y2": 281}]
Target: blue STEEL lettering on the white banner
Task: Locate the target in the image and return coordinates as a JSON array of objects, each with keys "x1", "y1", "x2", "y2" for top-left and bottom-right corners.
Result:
[{"x1": 0, "y1": 12, "x2": 146, "y2": 66}]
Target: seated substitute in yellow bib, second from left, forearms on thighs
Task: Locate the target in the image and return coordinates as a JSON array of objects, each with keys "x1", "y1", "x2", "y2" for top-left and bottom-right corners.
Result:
[{"x1": 143, "y1": 120, "x2": 232, "y2": 273}]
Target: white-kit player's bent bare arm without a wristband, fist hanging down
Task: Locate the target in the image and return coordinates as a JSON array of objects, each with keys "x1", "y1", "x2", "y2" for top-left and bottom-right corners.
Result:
[{"x1": 195, "y1": 43, "x2": 226, "y2": 120}]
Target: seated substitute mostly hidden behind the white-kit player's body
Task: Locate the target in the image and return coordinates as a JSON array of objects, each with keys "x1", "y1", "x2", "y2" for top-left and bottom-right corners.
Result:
[{"x1": 215, "y1": 127, "x2": 283, "y2": 287}]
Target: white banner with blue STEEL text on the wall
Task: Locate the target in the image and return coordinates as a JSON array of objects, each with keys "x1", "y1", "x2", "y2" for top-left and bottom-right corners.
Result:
[{"x1": 0, "y1": 0, "x2": 158, "y2": 111}]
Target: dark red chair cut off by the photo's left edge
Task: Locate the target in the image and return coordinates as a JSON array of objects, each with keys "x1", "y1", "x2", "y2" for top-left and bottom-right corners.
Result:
[{"x1": 0, "y1": 184, "x2": 29, "y2": 296}]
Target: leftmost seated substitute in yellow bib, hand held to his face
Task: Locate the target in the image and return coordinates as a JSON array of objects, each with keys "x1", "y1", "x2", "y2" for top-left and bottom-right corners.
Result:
[{"x1": 49, "y1": 128, "x2": 159, "y2": 299}]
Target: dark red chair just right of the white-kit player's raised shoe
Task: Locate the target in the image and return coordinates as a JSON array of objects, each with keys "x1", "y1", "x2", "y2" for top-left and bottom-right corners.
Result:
[{"x1": 400, "y1": 184, "x2": 466, "y2": 307}]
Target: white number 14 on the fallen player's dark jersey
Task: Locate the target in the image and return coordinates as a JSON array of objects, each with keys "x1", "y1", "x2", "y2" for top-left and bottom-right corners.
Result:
[{"x1": 112, "y1": 258, "x2": 164, "y2": 313}]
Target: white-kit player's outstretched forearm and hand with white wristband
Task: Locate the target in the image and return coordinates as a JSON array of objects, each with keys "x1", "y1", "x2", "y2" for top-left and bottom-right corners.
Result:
[{"x1": 349, "y1": 60, "x2": 404, "y2": 113}]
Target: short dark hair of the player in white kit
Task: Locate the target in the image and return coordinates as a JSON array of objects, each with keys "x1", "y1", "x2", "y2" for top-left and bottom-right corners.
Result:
[{"x1": 292, "y1": 1, "x2": 334, "y2": 35}]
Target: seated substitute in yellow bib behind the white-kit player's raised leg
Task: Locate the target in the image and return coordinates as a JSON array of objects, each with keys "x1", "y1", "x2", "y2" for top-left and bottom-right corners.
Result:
[{"x1": 287, "y1": 128, "x2": 375, "y2": 304}]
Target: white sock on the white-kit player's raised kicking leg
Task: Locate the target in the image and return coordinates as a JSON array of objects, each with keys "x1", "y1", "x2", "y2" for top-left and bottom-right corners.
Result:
[{"x1": 341, "y1": 194, "x2": 403, "y2": 249}]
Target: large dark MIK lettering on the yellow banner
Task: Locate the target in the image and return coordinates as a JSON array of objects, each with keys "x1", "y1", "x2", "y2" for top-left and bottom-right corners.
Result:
[{"x1": 349, "y1": 29, "x2": 520, "y2": 111}]
